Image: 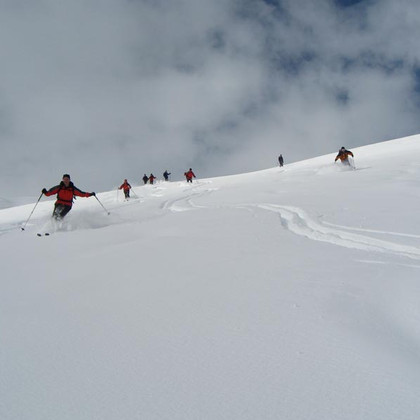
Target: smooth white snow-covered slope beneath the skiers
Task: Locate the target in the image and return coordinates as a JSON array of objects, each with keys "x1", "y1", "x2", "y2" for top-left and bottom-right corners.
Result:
[{"x1": 0, "y1": 136, "x2": 420, "y2": 420}]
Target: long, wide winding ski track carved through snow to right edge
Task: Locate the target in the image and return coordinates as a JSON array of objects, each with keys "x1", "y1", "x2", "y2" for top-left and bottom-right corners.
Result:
[{"x1": 162, "y1": 189, "x2": 420, "y2": 260}]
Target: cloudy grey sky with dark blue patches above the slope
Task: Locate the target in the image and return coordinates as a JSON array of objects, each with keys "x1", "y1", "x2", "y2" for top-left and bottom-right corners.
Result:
[{"x1": 0, "y1": 0, "x2": 420, "y2": 198}]
